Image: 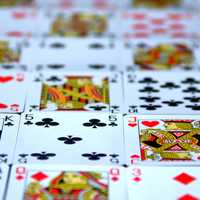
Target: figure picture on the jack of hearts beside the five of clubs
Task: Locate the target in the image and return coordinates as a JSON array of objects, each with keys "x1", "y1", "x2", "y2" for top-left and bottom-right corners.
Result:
[{"x1": 139, "y1": 119, "x2": 200, "y2": 161}]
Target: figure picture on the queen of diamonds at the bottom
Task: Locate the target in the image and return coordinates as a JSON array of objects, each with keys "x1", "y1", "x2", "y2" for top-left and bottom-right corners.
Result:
[{"x1": 23, "y1": 171, "x2": 109, "y2": 200}]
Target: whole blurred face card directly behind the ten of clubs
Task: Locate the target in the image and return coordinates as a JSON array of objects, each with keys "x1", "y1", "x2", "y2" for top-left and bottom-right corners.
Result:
[{"x1": 123, "y1": 39, "x2": 200, "y2": 71}]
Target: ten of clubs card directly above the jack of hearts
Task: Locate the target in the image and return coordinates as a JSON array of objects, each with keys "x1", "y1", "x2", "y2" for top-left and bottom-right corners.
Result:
[{"x1": 124, "y1": 72, "x2": 200, "y2": 115}]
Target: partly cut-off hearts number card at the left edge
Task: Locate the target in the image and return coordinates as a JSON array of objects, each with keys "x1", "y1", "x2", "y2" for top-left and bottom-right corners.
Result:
[{"x1": 0, "y1": 72, "x2": 28, "y2": 113}]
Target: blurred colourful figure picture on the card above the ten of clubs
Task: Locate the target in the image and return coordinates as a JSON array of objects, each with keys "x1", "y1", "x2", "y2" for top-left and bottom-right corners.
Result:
[{"x1": 134, "y1": 43, "x2": 195, "y2": 70}]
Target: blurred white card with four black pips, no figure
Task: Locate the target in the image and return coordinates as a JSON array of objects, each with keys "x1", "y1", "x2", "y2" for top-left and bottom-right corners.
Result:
[{"x1": 21, "y1": 37, "x2": 120, "y2": 71}]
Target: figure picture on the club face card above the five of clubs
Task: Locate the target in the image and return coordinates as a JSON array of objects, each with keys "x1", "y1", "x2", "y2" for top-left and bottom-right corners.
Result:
[{"x1": 40, "y1": 76, "x2": 109, "y2": 111}]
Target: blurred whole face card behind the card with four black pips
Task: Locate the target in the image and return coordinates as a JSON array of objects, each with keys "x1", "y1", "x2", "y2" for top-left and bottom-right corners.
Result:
[{"x1": 39, "y1": 8, "x2": 116, "y2": 38}]
